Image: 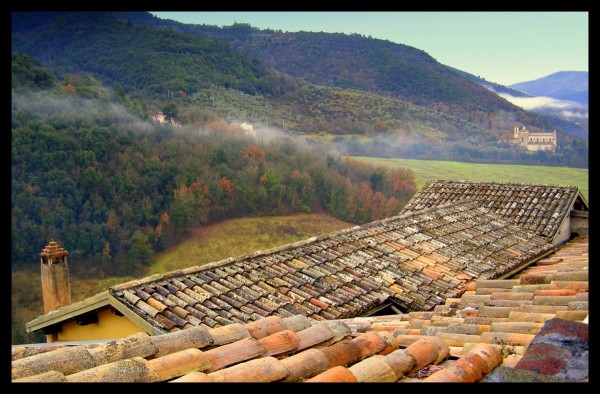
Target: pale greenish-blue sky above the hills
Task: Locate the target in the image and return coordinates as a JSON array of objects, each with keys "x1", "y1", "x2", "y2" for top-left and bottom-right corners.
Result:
[{"x1": 152, "y1": 11, "x2": 589, "y2": 85}]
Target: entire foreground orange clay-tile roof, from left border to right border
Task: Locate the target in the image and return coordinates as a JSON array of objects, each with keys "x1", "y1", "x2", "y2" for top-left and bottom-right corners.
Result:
[{"x1": 12, "y1": 237, "x2": 588, "y2": 382}]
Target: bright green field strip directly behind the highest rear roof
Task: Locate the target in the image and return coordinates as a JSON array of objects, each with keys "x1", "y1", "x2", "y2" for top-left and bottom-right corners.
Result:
[{"x1": 352, "y1": 156, "x2": 589, "y2": 202}]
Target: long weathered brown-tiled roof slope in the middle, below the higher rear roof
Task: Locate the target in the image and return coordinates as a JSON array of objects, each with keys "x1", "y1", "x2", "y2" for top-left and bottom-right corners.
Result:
[{"x1": 104, "y1": 202, "x2": 552, "y2": 332}]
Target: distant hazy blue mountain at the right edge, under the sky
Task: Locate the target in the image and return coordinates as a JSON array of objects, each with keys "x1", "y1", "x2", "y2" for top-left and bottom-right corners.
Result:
[{"x1": 510, "y1": 71, "x2": 589, "y2": 106}]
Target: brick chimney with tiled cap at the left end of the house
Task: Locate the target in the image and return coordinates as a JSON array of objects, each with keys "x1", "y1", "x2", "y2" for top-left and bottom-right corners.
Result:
[{"x1": 40, "y1": 240, "x2": 71, "y2": 314}]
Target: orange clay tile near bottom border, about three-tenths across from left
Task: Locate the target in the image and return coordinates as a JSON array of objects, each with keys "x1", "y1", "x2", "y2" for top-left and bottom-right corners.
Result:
[{"x1": 148, "y1": 349, "x2": 210, "y2": 381}]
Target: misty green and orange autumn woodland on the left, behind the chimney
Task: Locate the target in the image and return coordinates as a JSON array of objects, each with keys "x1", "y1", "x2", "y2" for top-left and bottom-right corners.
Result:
[{"x1": 12, "y1": 57, "x2": 415, "y2": 275}]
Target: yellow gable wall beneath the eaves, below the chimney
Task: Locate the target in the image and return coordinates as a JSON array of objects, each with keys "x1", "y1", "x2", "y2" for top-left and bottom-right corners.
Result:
[{"x1": 53, "y1": 309, "x2": 144, "y2": 342}]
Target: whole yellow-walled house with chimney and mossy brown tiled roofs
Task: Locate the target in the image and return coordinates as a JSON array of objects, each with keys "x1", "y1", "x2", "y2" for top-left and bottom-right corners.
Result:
[{"x1": 26, "y1": 181, "x2": 588, "y2": 342}]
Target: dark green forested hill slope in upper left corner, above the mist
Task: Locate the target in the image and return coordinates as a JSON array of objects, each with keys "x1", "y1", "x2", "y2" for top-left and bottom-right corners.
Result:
[{"x1": 12, "y1": 12, "x2": 296, "y2": 96}]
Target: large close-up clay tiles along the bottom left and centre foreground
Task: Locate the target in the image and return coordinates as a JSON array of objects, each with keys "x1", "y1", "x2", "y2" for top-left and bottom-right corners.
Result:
[{"x1": 12, "y1": 315, "x2": 501, "y2": 382}]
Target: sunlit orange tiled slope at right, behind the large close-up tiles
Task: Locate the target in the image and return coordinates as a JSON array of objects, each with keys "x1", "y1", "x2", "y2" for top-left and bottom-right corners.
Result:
[{"x1": 346, "y1": 237, "x2": 589, "y2": 378}]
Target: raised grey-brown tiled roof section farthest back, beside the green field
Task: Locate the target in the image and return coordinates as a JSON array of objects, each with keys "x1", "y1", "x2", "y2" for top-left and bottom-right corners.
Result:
[{"x1": 401, "y1": 180, "x2": 587, "y2": 239}]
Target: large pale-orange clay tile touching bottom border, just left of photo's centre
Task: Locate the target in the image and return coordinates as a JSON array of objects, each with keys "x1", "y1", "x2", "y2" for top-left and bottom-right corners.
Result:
[{"x1": 209, "y1": 357, "x2": 288, "y2": 383}]
